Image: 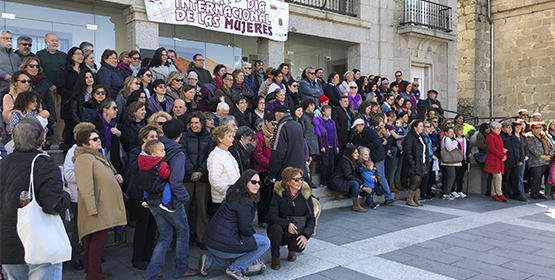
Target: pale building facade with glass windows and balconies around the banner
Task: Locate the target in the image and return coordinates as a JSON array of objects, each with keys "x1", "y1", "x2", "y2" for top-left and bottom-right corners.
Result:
[{"x1": 0, "y1": 0, "x2": 457, "y2": 110}]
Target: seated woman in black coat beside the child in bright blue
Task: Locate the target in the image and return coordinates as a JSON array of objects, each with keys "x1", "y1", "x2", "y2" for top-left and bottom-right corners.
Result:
[{"x1": 328, "y1": 147, "x2": 372, "y2": 212}]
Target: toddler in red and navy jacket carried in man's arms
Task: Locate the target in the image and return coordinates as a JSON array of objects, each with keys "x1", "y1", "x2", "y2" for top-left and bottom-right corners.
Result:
[{"x1": 138, "y1": 140, "x2": 175, "y2": 213}]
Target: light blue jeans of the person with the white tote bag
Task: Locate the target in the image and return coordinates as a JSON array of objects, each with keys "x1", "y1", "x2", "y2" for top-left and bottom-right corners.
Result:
[{"x1": 2, "y1": 263, "x2": 62, "y2": 280}]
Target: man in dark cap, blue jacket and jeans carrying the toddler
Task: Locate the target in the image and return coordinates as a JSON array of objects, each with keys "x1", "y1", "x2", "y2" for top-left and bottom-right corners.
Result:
[{"x1": 145, "y1": 119, "x2": 198, "y2": 280}]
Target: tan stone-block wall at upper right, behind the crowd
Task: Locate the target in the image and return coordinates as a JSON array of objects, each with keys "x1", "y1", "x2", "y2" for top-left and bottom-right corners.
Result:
[{"x1": 458, "y1": 0, "x2": 555, "y2": 120}]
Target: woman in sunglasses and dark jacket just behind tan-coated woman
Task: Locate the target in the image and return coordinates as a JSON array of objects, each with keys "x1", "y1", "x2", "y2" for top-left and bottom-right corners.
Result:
[{"x1": 91, "y1": 98, "x2": 124, "y2": 174}]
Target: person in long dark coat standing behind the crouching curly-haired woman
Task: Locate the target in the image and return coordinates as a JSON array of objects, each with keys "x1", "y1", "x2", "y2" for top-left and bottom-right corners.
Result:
[{"x1": 268, "y1": 106, "x2": 307, "y2": 181}]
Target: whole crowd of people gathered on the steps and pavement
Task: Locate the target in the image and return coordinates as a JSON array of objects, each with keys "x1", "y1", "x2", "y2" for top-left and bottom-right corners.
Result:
[{"x1": 0, "y1": 30, "x2": 555, "y2": 280}]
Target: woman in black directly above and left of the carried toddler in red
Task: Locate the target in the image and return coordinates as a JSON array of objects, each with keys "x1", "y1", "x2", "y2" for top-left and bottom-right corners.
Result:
[{"x1": 119, "y1": 101, "x2": 146, "y2": 154}]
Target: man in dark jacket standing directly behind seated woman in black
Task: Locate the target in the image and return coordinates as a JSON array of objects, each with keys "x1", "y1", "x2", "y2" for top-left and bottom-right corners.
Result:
[{"x1": 331, "y1": 95, "x2": 354, "y2": 159}]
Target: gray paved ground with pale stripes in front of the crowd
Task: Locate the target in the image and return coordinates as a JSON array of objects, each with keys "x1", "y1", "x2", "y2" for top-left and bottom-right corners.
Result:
[{"x1": 63, "y1": 196, "x2": 555, "y2": 280}]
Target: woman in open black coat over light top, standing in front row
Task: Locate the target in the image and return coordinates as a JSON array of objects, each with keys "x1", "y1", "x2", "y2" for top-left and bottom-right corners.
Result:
[{"x1": 403, "y1": 119, "x2": 429, "y2": 206}]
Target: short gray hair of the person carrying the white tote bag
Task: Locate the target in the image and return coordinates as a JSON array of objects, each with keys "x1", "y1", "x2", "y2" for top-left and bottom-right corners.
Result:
[{"x1": 12, "y1": 116, "x2": 46, "y2": 152}]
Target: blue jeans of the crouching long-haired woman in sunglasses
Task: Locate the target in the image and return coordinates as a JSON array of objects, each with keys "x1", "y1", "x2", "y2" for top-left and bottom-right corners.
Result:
[{"x1": 206, "y1": 234, "x2": 270, "y2": 271}]
